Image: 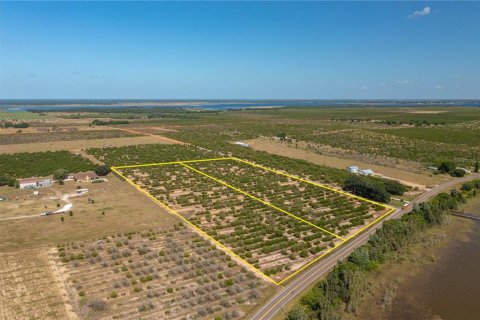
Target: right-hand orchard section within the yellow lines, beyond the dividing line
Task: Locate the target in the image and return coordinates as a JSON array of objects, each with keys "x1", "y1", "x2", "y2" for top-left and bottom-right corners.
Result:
[{"x1": 188, "y1": 160, "x2": 385, "y2": 237}]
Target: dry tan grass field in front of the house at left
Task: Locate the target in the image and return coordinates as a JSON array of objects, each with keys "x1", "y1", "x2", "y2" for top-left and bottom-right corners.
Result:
[{"x1": 0, "y1": 175, "x2": 175, "y2": 251}]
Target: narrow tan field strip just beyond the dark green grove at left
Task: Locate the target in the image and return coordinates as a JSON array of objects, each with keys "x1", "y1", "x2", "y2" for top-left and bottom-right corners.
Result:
[{"x1": 2, "y1": 136, "x2": 176, "y2": 153}]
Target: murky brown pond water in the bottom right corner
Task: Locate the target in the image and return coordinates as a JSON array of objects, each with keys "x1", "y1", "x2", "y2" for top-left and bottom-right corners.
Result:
[{"x1": 386, "y1": 219, "x2": 480, "y2": 320}]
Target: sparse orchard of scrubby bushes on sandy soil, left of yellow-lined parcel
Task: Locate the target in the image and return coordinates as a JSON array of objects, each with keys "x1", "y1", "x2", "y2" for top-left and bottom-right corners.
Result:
[{"x1": 57, "y1": 225, "x2": 271, "y2": 319}]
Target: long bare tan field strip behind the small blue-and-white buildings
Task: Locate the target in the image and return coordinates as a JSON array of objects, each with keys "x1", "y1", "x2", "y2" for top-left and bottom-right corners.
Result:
[{"x1": 248, "y1": 139, "x2": 451, "y2": 188}]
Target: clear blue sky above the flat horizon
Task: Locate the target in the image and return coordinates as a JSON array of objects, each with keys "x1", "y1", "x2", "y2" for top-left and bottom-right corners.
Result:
[{"x1": 0, "y1": 1, "x2": 480, "y2": 99}]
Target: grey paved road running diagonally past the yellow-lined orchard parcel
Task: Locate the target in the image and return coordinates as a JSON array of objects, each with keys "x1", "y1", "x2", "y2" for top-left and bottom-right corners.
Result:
[{"x1": 252, "y1": 173, "x2": 480, "y2": 320}]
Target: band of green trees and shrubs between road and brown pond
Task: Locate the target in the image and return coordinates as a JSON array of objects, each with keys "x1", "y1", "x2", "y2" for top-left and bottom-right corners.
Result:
[{"x1": 286, "y1": 180, "x2": 480, "y2": 320}]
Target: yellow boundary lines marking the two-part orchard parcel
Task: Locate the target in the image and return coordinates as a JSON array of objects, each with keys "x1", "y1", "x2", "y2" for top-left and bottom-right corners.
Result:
[{"x1": 111, "y1": 157, "x2": 395, "y2": 285}]
